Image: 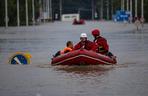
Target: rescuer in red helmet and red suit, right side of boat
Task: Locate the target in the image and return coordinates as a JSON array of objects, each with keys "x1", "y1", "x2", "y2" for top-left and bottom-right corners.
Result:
[{"x1": 92, "y1": 29, "x2": 116, "y2": 58}]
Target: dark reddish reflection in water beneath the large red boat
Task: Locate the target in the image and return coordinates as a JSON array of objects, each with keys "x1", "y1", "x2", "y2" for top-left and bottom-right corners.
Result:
[{"x1": 49, "y1": 65, "x2": 114, "y2": 79}]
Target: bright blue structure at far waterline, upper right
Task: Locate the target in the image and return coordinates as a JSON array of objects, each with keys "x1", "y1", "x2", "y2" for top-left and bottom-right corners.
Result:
[{"x1": 113, "y1": 10, "x2": 130, "y2": 22}]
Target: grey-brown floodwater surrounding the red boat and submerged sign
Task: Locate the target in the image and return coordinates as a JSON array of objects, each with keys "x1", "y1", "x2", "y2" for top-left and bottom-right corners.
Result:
[{"x1": 0, "y1": 21, "x2": 148, "y2": 96}]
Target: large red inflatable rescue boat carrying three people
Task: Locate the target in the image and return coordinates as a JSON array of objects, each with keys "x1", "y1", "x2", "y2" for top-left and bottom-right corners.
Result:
[{"x1": 51, "y1": 49, "x2": 117, "y2": 65}]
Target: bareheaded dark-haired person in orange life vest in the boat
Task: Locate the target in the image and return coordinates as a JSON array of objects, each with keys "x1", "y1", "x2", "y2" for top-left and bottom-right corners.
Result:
[{"x1": 54, "y1": 41, "x2": 73, "y2": 57}]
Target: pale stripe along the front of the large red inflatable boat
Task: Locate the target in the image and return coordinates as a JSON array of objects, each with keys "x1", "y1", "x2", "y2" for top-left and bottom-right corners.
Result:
[{"x1": 53, "y1": 55, "x2": 113, "y2": 65}]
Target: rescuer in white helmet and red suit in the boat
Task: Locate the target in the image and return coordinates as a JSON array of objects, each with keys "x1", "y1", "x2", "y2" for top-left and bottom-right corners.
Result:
[{"x1": 74, "y1": 33, "x2": 96, "y2": 51}]
